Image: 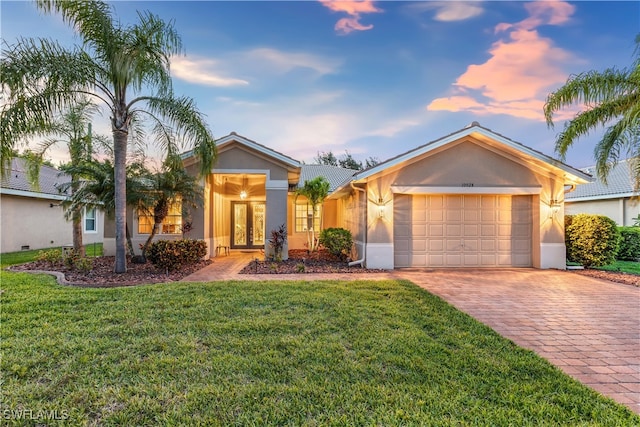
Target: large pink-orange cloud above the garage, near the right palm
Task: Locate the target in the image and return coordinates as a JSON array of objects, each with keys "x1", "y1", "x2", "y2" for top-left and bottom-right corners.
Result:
[{"x1": 427, "y1": 2, "x2": 577, "y2": 120}]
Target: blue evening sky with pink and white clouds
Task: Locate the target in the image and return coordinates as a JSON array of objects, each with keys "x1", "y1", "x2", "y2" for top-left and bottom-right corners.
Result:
[{"x1": 0, "y1": 0, "x2": 640, "y2": 167}]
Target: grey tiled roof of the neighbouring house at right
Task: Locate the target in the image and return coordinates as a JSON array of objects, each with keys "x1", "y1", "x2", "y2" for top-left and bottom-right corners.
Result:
[{"x1": 565, "y1": 159, "x2": 635, "y2": 202}]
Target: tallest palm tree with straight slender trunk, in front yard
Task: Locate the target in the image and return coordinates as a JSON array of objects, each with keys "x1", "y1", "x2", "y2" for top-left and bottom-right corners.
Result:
[{"x1": 0, "y1": 0, "x2": 216, "y2": 273}]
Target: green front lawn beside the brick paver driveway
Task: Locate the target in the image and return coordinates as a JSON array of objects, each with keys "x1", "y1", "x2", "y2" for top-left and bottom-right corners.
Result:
[{"x1": 0, "y1": 272, "x2": 640, "y2": 426}]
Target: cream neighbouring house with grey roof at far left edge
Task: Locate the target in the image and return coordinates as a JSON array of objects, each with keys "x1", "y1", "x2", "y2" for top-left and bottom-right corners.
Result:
[{"x1": 0, "y1": 158, "x2": 104, "y2": 253}]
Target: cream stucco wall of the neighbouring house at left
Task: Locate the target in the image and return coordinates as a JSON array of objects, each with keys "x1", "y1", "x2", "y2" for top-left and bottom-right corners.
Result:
[{"x1": 0, "y1": 195, "x2": 104, "y2": 252}]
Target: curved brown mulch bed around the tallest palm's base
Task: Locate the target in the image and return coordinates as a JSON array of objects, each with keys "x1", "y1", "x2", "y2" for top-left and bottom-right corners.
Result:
[{"x1": 10, "y1": 257, "x2": 211, "y2": 288}]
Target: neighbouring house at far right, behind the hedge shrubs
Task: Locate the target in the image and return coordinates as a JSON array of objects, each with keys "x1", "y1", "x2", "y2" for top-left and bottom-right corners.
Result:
[{"x1": 565, "y1": 160, "x2": 640, "y2": 226}]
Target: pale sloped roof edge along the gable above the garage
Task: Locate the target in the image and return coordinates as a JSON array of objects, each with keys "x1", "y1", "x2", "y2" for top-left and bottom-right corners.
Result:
[{"x1": 354, "y1": 122, "x2": 591, "y2": 183}]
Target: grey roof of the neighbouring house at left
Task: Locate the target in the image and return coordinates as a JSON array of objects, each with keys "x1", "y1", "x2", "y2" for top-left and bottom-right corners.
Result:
[{"x1": 0, "y1": 158, "x2": 71, "y2": 200}]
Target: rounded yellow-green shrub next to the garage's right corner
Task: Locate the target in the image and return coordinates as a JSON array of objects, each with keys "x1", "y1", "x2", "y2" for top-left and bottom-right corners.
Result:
[{"x1": 565, "y1": 214, "x2": 620, "y2": 267}]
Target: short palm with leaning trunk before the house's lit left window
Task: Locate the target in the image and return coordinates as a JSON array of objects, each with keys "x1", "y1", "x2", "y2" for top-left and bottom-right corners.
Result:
[{"x1": 139, "y1": 157, "x2": 204, "y2": 259}]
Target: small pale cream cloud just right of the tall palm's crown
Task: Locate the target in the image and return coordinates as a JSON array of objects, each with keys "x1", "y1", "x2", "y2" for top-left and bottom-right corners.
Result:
[{"x1": 171, "y1": 56, "x2": 249, "y2": 87}]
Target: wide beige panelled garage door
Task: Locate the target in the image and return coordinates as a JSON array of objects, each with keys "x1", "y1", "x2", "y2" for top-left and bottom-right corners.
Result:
[{"x1": 394, "y1": 194, "x2": 532, "y2": 267}]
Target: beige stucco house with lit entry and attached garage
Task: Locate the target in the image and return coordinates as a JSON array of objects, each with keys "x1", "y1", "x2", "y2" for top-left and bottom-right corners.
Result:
[{"x1": 105, "y1": 122, "x2": 590, "y2": 269}]
